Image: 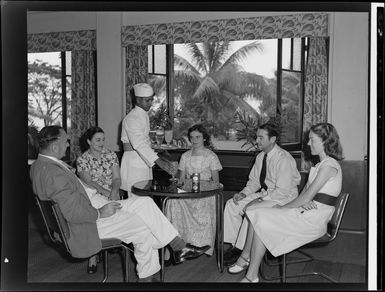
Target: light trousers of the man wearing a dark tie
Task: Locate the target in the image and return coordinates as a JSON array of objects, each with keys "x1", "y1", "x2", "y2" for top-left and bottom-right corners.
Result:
[{"x1": 223, "y1": 193, "x2": 278, "y2": 250}]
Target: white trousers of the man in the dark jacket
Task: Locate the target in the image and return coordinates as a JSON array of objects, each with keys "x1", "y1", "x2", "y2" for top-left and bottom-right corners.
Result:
[{"x1": 91, "y1": 194, "x2": 178, "y2": 278}]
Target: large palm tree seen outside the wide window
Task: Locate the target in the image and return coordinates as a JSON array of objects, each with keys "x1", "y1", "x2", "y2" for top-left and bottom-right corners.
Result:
[{"x1": 174, "y1": 41, "x2": 276, "y2": 138}]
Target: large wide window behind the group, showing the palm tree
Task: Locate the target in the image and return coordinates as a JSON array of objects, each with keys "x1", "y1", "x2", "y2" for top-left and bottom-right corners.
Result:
[{"x1": 149, "y1": 38, "x2": 306, "y2": 150}]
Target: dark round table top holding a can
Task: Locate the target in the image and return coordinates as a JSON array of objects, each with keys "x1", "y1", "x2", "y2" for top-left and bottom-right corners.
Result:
[{"x1": 132, "y1": 179, "x2": 223, "y2": 198}]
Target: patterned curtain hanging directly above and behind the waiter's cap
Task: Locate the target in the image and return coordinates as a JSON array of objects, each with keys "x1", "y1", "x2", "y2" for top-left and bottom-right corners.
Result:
[{"x1": 125, "y1": 45, "x2": 148, "y2": 113}]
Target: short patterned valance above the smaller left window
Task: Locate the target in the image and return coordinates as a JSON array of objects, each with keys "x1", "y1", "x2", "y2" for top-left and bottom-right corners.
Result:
[{"x1": 27, "y1": 30, "x2": 96, "y2": 53}]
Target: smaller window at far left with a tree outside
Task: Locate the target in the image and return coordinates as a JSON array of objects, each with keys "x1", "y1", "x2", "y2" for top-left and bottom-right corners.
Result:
[{"x1": 28, "y1": 51, "x2": 71, "y2": 157}]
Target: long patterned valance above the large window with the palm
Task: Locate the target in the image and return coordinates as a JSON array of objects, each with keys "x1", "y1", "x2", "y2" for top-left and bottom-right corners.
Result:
[{"x1": 122, "y1": 13, "x2": 328, "y2": 47}]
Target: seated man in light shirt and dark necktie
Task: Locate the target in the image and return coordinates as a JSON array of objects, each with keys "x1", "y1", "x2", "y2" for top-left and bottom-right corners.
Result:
[{"x1": 224, "y1": 123, "x2": 301, "y2": 266}]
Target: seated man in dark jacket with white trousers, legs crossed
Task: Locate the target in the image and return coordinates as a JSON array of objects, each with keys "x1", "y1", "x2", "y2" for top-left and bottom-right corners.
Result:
[{"x1": 30, "y1": 126, "x2": 210, "y2": 282}]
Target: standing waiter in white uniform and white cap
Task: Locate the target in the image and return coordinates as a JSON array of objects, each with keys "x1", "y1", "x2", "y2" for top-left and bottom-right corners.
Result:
[{"x1": 120, "y1": 83, "x2": 178, "y2": 196}]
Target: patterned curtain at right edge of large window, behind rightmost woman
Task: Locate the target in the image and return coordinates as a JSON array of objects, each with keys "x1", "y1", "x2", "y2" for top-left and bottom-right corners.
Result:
[{"x1": 301, "y1": 37, "x2": 329, "y2": 171}]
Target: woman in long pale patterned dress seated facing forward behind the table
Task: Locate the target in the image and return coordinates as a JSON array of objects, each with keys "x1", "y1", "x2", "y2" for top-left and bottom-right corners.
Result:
[{"x1": 165, "y1": 124, "x2": 222, "y2": 256}]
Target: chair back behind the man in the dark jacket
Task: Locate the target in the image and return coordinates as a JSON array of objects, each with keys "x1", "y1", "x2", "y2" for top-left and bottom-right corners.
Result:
[{"x1": 35, "y1": 195, "x2": 71, "y2": 253}]
